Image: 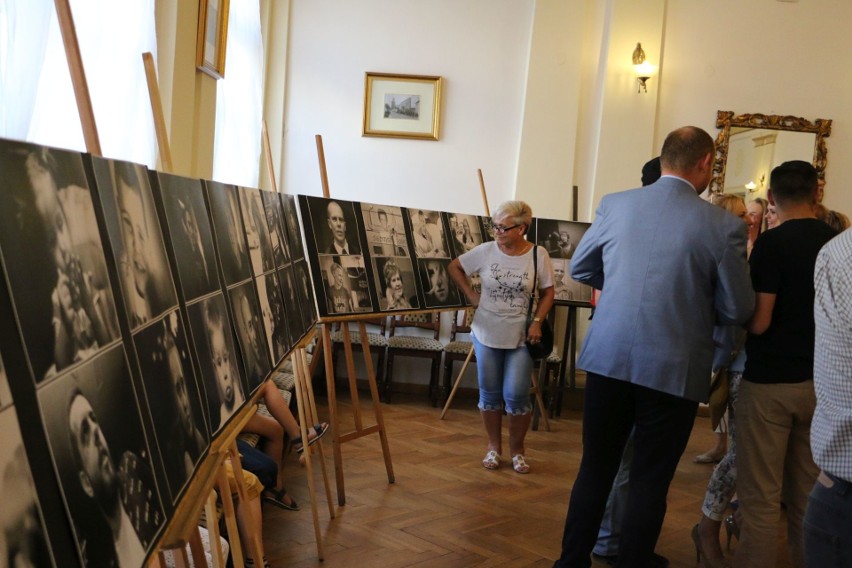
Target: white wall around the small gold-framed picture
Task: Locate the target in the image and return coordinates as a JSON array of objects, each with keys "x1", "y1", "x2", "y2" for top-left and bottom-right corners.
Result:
[{"x1": 279, "y1": 0, "x2": 534, "y2": 214}]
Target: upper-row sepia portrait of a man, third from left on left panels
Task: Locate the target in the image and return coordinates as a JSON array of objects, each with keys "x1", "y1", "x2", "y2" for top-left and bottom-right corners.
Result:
[{"x1": 156, "y1": 172, "x2": 219, "y2": 302}]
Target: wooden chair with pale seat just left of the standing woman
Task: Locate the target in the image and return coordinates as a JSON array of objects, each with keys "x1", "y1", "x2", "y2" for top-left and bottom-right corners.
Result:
[{"x1": 382, "y1": 312, "x2": 444, "y2": 406}]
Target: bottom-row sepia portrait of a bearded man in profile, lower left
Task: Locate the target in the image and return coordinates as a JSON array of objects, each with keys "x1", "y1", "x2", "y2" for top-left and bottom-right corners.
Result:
[{"x1": 38, "y1": 345, "x2": 165, "y2": 567}]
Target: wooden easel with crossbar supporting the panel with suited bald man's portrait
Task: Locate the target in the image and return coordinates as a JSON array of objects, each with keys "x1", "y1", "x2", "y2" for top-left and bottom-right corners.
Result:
[{"x1": 312, "y1": 138, "x2": 395, "y2": 506}]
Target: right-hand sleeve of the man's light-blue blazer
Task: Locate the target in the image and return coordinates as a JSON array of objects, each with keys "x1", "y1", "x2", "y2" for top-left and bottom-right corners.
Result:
[{"x1": 715, "y1": 223, "x2": 754, "y2": 325}]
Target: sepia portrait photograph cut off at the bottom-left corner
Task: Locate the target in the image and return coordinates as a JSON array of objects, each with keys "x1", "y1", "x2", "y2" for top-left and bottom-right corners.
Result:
[{"x1": 0, "y1": 407, "x2": 56, "y2": 568}]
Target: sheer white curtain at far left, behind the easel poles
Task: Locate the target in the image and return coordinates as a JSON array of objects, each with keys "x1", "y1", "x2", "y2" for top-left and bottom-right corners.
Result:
[{"x1": 0, "y1": 0, "x2": 157, "y2": 167}]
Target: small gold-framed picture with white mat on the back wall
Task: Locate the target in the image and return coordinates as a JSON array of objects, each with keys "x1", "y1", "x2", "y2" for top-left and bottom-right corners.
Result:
[{"x1": 361, "y1": 72, "x2": 444, "y2": 140}]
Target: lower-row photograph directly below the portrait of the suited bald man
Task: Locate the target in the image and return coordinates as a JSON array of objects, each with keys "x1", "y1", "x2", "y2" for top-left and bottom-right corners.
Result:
[{"x1": 319, "y1": 255, "x2": 373, "y2": 315}]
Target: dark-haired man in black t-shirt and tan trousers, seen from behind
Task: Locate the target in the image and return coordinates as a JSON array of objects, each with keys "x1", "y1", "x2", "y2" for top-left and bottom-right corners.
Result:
[{"x1": 734, "y1": 160, "x2": 835, "y2": 568}]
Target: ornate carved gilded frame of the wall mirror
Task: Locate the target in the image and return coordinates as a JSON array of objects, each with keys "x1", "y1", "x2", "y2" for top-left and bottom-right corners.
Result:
[{"x1": 710, "y1": 110, "x2": 831, "y2": 193}]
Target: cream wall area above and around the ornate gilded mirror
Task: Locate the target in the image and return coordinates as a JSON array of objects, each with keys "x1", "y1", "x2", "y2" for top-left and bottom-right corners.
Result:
[{"x1": 655, "y1": 0, "x2": 852, "y2": 214}]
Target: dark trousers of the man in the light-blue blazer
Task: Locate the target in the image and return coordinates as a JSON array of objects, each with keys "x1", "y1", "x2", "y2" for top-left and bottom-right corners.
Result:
[{"x1": 554, "y1": 373, "x2": 698, "y2": 568}]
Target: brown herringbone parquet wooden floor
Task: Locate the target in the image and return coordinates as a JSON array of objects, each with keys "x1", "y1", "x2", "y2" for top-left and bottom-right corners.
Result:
[{"x1": 263, "y1": 394, "x2": 789, "y2": 568}]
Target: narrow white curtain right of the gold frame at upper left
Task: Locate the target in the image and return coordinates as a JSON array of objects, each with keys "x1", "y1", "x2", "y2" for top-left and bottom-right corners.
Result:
[{"x1": 213, "y1": 0, "x2": 263, "y2": 187}]
